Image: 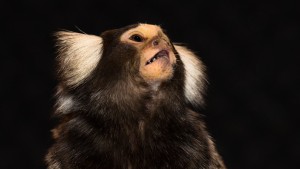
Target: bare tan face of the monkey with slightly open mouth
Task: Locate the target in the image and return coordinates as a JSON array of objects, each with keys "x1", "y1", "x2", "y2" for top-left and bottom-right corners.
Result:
[{"x1": 121, "y1": 24, "x2": 176, "y2": 83}]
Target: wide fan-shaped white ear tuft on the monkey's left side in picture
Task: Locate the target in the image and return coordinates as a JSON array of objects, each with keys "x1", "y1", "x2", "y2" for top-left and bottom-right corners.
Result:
[{"x1": 56, "y1": 31, "x2": 103, "y2": 86}]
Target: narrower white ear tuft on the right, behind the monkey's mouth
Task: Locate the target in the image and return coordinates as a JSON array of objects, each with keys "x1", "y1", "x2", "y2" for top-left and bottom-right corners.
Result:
[{"x1": 175, "y1": 45, "x2": 207, "y2": 106}]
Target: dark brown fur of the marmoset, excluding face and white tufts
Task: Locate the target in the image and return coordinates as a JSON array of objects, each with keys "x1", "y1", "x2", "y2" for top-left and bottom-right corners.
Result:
[{"x1": 46, "y1": 25, "x2": 225, "y2": 169}]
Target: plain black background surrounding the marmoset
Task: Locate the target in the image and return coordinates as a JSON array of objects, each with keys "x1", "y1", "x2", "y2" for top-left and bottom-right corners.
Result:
[{"x1": 0, "y1": 0, "x2": 300, "y2": 169}]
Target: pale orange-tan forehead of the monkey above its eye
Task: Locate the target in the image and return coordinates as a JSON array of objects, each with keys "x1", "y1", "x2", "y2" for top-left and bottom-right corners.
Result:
[{"x1": 121, "y1": 24, "x2": 163, "y2": 41}]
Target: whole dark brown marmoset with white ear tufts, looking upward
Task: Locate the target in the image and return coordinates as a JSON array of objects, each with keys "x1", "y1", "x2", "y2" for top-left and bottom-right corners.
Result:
[{"x1": 46, "y1": 24, "x2": 225, "y2": 169}]
